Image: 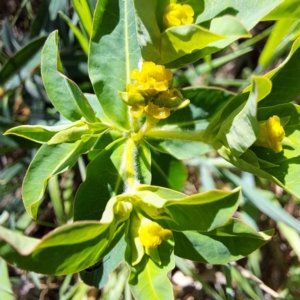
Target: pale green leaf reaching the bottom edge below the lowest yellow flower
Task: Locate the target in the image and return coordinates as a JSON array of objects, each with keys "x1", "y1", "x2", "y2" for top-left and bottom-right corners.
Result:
[{"x1": 129, "y1": 241, "x2": 175, "y2": 300}]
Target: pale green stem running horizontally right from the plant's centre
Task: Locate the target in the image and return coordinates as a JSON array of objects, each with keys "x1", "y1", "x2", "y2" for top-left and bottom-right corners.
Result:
[{"x1": 145, "y1": 130, "x2": 205, "y2": 142}]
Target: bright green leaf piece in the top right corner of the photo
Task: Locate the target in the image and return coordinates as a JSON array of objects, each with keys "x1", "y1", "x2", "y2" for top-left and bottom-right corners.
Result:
[{"x1": 263, "y1": 0, "x2": 300, "y2": 21}]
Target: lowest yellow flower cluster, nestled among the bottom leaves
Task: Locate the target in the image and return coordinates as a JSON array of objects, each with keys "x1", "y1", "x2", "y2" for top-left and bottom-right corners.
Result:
[{"x1": 139, "y1": 218, "x2": 172, "y2": 248}]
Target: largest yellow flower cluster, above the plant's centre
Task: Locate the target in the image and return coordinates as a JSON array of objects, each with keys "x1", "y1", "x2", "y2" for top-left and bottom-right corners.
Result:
[{"x1": 127, "y1": 62, "x2": 173, "y2": 96}]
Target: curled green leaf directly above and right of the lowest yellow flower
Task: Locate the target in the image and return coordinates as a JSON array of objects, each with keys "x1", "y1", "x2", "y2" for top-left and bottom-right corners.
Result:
[{"x1": 136, "y1": 185, "x2": 240, "y2": 231}]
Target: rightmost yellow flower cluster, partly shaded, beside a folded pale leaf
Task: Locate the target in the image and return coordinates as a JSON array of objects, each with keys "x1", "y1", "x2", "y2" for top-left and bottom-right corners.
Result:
[{"x1": 255, "y1": 116, "x2": 285, "y2": 153}]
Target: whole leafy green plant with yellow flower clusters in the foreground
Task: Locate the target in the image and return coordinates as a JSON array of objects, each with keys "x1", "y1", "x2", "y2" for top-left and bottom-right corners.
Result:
[{"x1": 0, "y1": 0, "x2": 300, "y2": 299}]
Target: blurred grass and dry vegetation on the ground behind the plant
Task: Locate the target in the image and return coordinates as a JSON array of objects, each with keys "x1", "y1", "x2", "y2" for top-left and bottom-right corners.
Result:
[{"x1": 0, "y1": 0, "x2": 300, "y2": 300}]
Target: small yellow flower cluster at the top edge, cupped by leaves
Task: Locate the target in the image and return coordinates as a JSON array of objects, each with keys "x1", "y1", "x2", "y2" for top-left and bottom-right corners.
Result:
[{"x1": 163, "y1": 3, "x2": 194, "y2": 28}]
